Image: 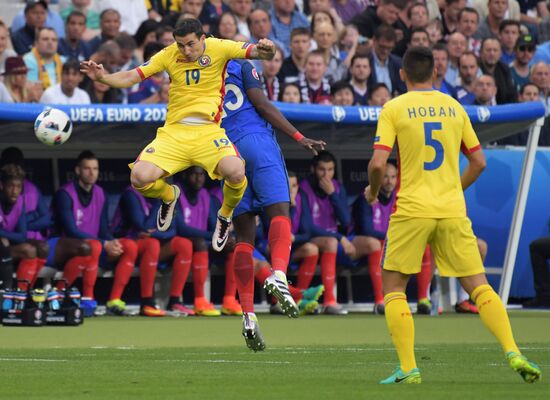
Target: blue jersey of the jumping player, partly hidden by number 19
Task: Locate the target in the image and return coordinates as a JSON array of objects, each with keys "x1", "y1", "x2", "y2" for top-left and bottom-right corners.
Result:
[{"x1": 222, "y1": 60, "x2": 273, "y2": 143}]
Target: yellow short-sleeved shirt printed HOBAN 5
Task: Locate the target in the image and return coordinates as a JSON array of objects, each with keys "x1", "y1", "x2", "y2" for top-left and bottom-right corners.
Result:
[{"x1": 374, "y1": 90, "x2": 480, "y2": 218}]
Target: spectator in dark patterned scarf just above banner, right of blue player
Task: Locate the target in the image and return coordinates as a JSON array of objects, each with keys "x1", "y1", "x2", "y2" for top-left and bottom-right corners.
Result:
[{"x1": 298, "y1": 50, "x2": 330, "y2": 104}]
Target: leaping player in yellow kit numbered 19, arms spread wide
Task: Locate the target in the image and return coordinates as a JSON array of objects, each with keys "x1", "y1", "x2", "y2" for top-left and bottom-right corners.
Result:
[{"x1": 81, "y1": 18, "x2": 275, "y2": 251}]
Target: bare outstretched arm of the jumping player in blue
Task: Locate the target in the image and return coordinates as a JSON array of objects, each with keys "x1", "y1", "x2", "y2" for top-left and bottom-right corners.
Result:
[{"x1": 246, "y1": 88, "x2": 326, "y2": 155}]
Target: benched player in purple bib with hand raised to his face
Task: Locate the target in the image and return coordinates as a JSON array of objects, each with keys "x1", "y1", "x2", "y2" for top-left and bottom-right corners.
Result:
[{"x1": 300, "y1": 150, "x2": 356, "y2": 315}]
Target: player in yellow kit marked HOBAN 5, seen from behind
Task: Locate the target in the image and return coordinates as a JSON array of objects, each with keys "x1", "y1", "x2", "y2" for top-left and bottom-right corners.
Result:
[{"x1": 365, "y1": 47, "x2": 541, "y2": 384}]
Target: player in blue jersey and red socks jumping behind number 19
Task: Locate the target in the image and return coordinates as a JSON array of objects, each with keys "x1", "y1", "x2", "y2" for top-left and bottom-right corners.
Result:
[{"x1": 222, "y1": 60, "x2": 325, "y2": 351}]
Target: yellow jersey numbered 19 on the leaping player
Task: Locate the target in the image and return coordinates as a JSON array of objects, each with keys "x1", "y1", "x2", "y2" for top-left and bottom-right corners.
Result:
[{"x1": 136, "y1": 38, "x2": 254, "y2": 125}]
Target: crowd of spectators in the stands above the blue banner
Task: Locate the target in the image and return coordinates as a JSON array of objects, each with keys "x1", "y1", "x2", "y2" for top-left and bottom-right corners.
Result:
[{"x1": 0, "y1": 0, "x2": 550, "y2": 145}]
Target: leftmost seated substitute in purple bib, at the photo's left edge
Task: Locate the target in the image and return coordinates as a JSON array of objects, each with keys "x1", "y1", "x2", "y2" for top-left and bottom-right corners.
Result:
[{"x1": 0, "y1": 164, "x2": 49, "y2": 289}]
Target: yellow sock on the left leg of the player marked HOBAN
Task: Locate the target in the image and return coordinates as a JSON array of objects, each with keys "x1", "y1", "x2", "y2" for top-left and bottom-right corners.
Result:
[{"x1": 384, "y1": 292, "x2": 416, "y2": 373}]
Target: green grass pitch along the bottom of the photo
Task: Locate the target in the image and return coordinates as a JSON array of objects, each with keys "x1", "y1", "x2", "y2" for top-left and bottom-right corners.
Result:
[{"x1": 0, "y1": 312, "x2": 550, "y2": 400}]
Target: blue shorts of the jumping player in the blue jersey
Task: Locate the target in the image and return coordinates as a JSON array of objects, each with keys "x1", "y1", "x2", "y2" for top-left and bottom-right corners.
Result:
[{"x1": 233, "y1": 133, "x2": 290, "y2": 216}]
